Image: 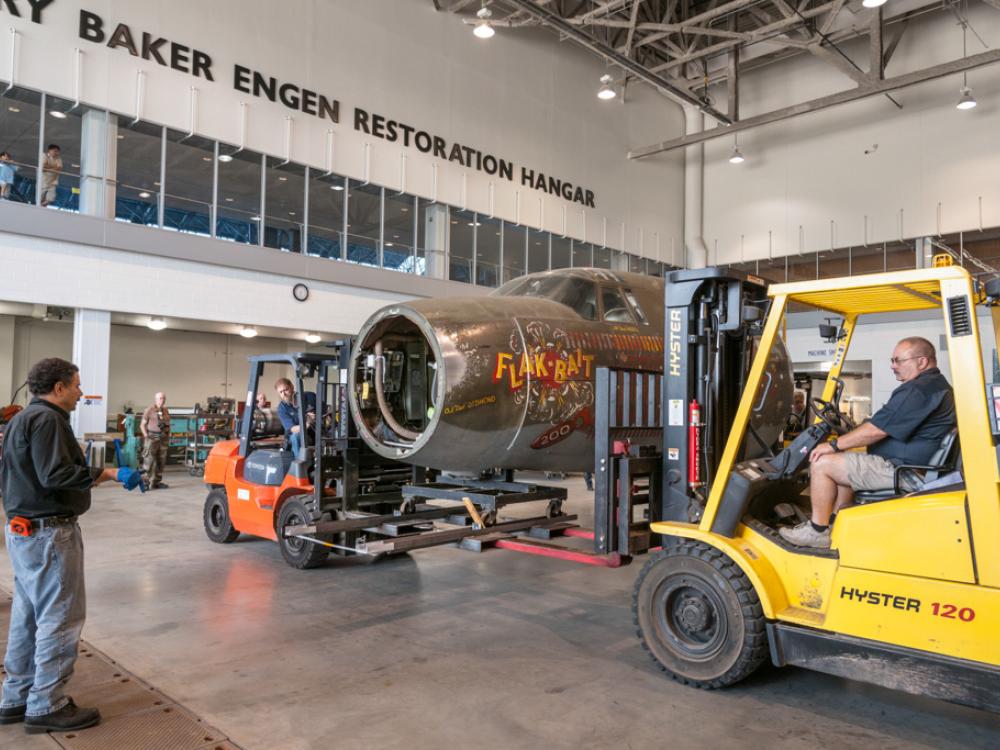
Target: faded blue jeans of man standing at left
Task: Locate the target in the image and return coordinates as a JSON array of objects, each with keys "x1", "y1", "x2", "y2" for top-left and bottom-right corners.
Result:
[{"x1": 0, "y1": 523, "x2": 87, "y2": 716}]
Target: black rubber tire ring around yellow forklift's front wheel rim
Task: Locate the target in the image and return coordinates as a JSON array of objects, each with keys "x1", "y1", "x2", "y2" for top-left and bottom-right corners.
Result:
[{"x1": 632, "y1": 538, "x2": 770, "y2": 690}]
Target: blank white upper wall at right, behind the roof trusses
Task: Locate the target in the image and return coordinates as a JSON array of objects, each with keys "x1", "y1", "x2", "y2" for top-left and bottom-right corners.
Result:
[{"x1": 705, "y1": 3, "x2": 1000, "y2": 263}]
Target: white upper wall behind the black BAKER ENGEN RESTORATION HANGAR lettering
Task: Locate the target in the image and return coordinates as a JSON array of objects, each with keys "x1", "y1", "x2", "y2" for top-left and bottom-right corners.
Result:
[{"x1": 0, "y1": 0, "x2": 683, "y2": 259}]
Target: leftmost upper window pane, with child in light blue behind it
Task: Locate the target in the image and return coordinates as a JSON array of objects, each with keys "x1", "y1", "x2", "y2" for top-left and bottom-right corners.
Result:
[{"x1": 0, "y1": 88, "x2": 42, "y2": 203}]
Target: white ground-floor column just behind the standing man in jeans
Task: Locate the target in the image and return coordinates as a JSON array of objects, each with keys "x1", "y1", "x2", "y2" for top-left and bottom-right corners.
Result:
[{"x1": 70, "y1": 309, "x2": 111, "y2": 440}]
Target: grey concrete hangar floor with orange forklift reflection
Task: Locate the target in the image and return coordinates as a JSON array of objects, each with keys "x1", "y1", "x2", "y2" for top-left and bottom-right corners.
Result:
[{"x1": 0, "y1": 472, "x2": 1000, "y2": 750}]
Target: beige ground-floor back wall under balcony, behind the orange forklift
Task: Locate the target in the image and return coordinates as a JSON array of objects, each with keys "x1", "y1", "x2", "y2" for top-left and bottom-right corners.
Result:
[{"x1": 7, "y1": 318, "x2": 322, "y2": 414}]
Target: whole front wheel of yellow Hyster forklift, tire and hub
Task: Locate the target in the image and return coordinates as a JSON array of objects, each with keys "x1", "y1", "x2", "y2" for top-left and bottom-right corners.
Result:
[{"x1": 632, "y1": 539, "x2": 768, "y2": 690}]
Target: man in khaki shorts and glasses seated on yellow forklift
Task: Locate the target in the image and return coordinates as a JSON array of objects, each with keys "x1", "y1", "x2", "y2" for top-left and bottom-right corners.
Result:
[{"x1": 780, "y1": 336, "x2": 956, "y2": 547}]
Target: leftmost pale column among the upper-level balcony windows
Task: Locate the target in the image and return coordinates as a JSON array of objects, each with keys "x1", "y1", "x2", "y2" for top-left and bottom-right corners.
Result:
[{"x1": 80, "y1": 110, "x2": 118, "y2": 219}]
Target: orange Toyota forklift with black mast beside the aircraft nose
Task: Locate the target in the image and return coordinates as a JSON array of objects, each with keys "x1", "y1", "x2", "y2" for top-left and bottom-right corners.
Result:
[{"x1": 204, "y1": 350, "x2": 423, "y2": 568}]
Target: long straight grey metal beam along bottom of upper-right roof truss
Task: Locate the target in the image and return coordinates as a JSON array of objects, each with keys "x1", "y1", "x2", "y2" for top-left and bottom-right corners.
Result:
[{"x1": 628, "y1": 49, "x2": 1000, "y2": 159}]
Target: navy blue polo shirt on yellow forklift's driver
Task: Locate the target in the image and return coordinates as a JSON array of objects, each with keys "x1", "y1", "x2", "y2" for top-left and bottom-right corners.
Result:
[{"x1": 868, "y1": 367, "x2": 956, "y2": 466}]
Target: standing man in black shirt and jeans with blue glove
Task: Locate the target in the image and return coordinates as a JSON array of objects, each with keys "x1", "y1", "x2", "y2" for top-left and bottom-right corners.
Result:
[{"x1": 0, "y1": 358, "x2": 141, "y2": 734}]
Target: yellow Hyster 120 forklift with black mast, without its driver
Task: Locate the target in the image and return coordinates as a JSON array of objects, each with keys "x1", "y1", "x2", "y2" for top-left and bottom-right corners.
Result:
[{"x1": 634, "y1": 258, "x2": 1000, "y2": 711}]
